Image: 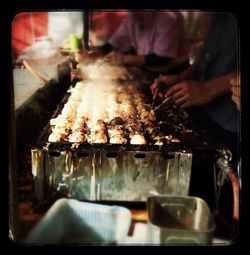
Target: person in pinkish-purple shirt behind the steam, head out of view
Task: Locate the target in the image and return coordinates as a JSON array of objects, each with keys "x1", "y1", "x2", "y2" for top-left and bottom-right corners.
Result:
[{"x1": 75, "y1": 11, "x2": 189, "y2": 74}]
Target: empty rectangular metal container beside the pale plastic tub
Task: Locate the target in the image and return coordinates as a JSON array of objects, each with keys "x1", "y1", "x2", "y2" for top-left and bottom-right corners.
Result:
[{"x1": 147, "y1": 196, "x2": 215, "y2": 244}]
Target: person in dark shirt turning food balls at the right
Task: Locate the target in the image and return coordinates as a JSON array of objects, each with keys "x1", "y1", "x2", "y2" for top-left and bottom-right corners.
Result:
[{"x1": 150, "y1": 13, "x2": 239, "y2": 167}]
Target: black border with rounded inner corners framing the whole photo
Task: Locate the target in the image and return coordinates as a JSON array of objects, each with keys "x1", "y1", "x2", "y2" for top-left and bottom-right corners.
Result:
[{"x1": 0, "y1": 0, "x2": 247, "y2": 254}]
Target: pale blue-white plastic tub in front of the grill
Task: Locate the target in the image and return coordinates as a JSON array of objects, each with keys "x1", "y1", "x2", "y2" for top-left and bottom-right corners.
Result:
[{"x1": 26, "y1": 199, "x2": 131, "y2": 244}]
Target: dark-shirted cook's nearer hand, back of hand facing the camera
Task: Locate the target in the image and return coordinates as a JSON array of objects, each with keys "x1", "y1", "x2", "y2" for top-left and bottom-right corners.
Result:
[{"x1": 165, "y1": 80, "x2": 213, "y2": 108}]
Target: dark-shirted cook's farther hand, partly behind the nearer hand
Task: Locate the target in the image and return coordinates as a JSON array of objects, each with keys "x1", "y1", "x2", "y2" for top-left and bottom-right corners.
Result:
[{"x1": 150, "y1": 75, "x2": 179, "y2": 98}]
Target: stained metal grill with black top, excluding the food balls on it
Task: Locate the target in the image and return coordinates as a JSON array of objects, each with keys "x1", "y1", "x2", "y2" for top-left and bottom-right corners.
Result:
[{"x1": 31, "y1": 65, "x2": 225, "y2": 207}]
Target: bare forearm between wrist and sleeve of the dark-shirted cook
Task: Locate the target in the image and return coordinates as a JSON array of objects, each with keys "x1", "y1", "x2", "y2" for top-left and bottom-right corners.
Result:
[{"x1": 205, "y1": 71, "x2": 236, "y2": 100}]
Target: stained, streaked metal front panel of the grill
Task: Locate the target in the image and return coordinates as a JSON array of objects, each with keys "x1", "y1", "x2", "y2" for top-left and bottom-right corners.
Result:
[{"x1": 32, "y1": 149, "x2": 192, "y2": 202}]
